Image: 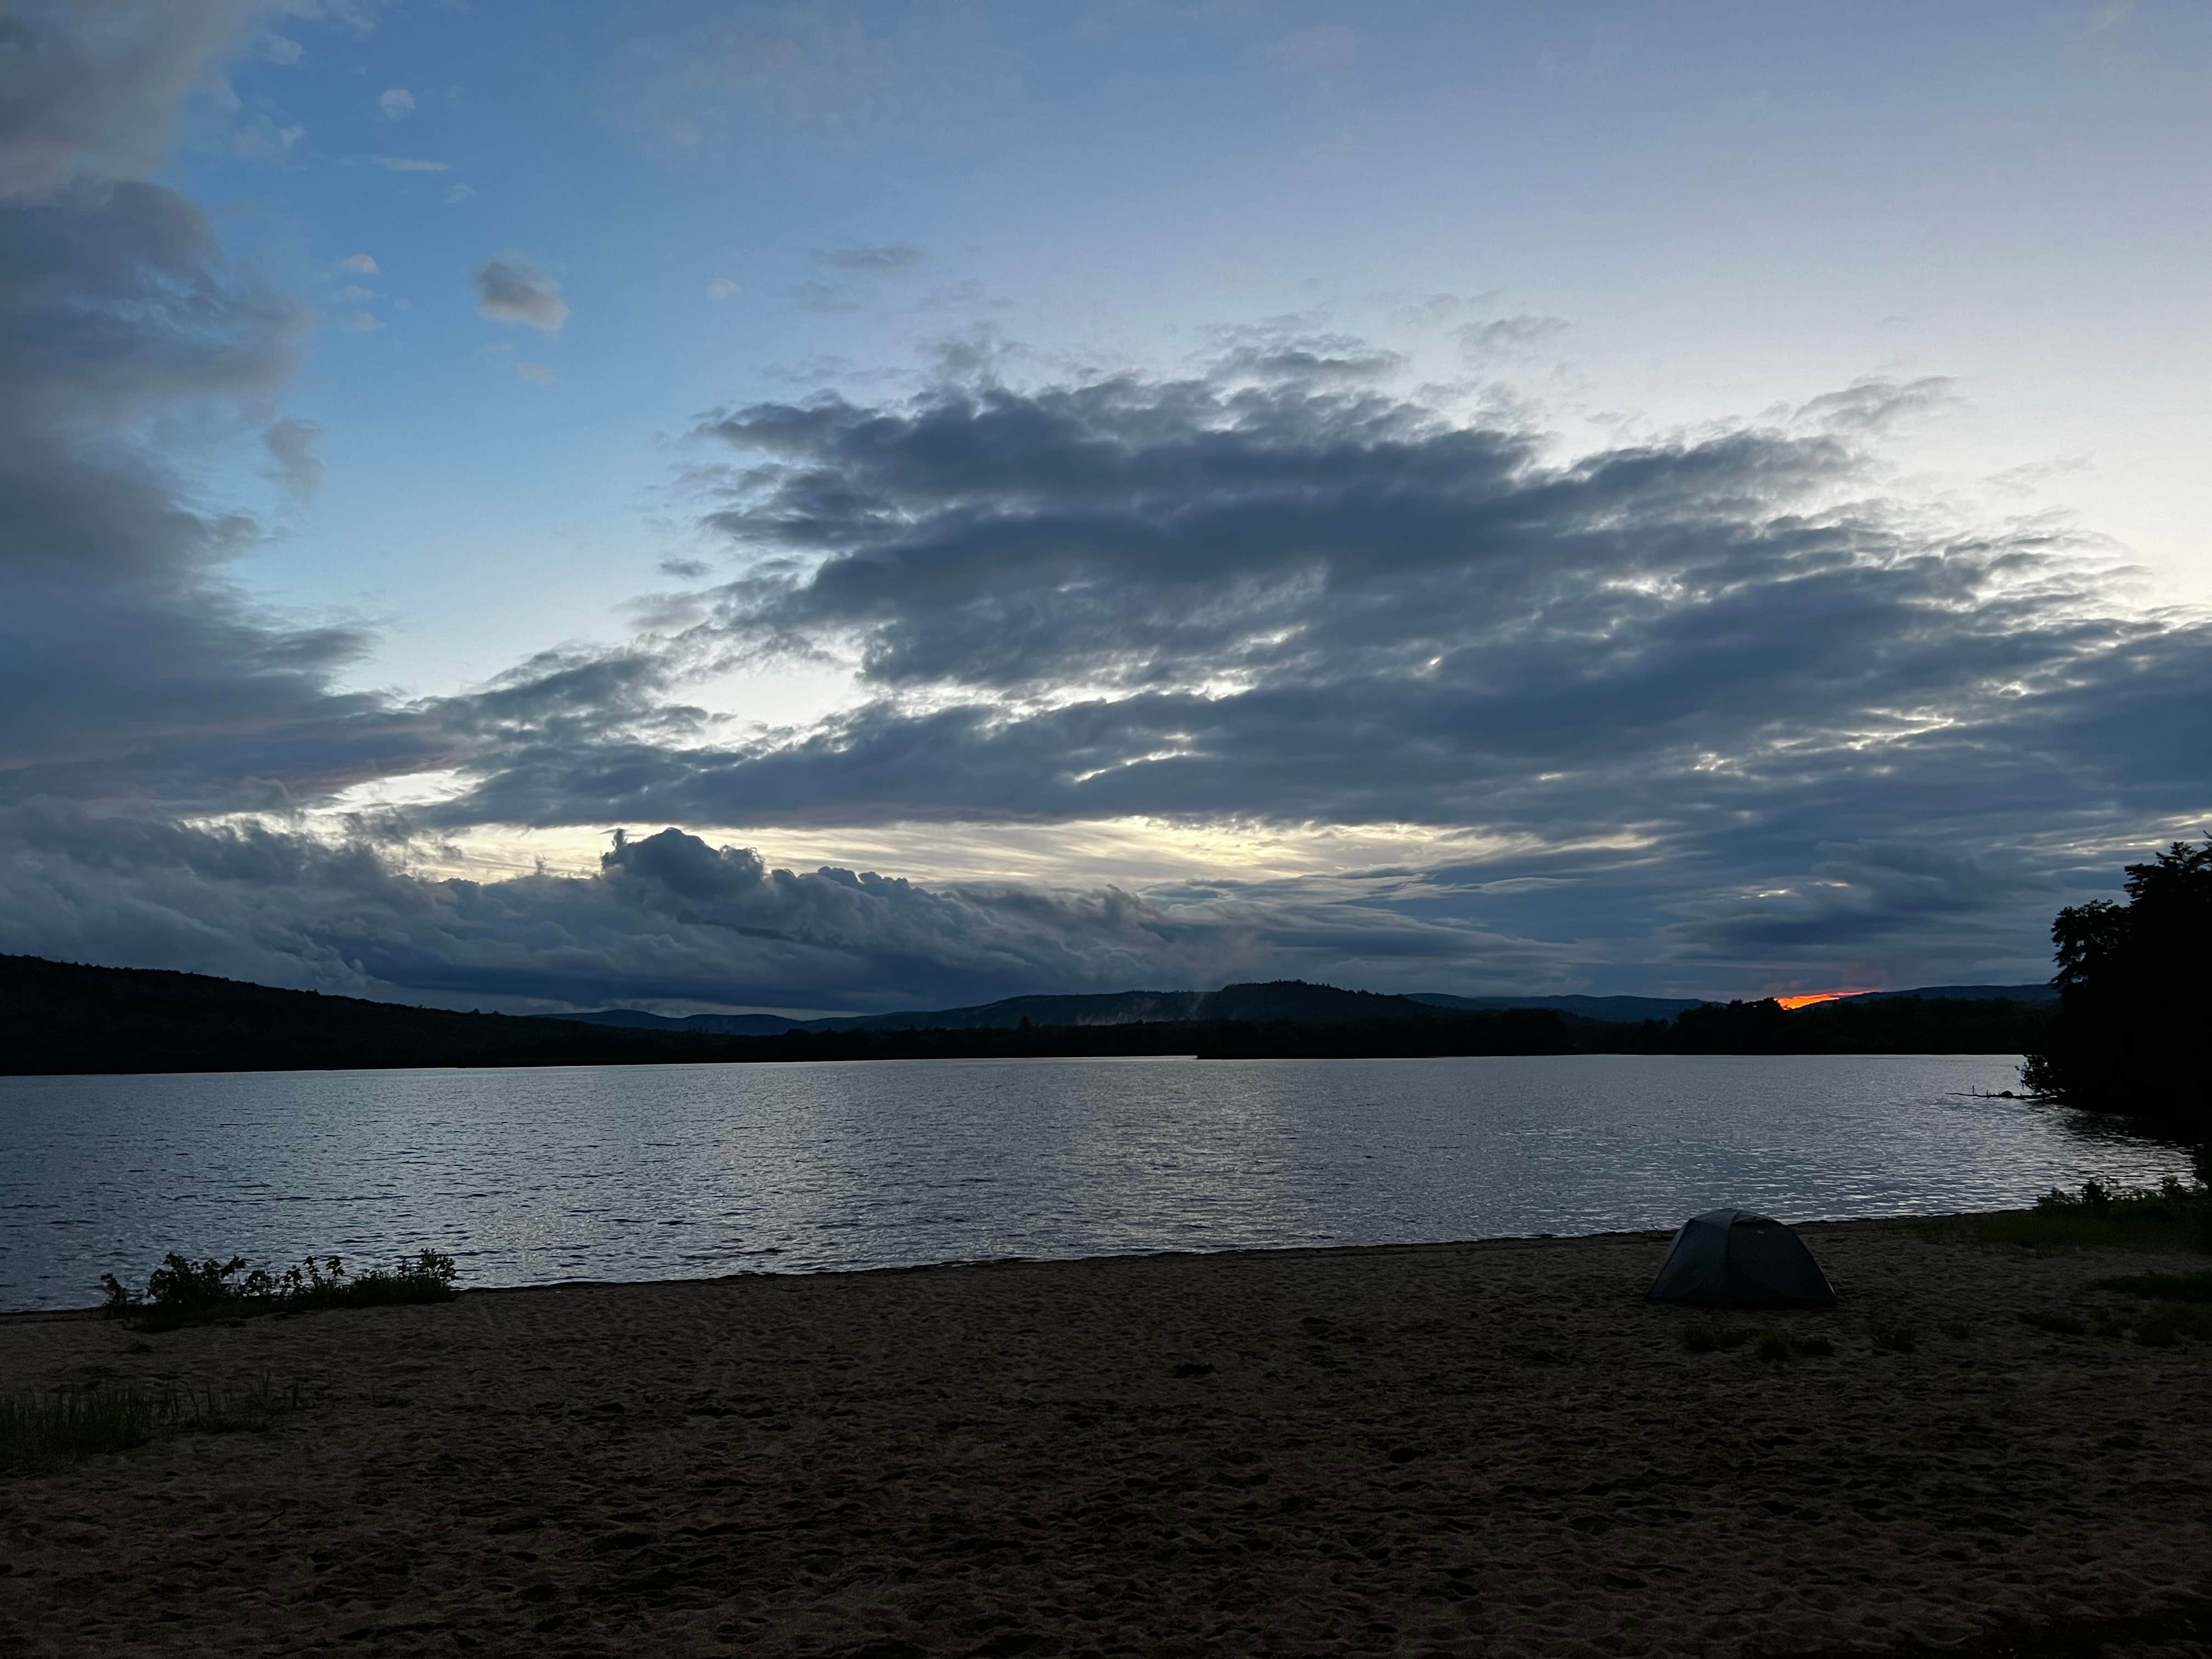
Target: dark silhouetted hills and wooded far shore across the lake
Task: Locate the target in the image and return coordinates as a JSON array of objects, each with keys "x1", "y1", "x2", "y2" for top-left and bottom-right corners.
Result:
[{"x1": 0, "y1": 956, "x2": 2055, "y2": 1075}]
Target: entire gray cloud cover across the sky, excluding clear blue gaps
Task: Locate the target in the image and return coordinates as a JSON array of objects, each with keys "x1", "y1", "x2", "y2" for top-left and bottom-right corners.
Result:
[{"x1": 0, "y1": 4, "x2": 2212, "y2": 1007}]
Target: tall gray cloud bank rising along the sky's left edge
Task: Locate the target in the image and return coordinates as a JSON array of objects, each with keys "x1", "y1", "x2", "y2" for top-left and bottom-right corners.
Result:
[{"x1": 0, "y1": 7, "x2": 453, "y2": 808}]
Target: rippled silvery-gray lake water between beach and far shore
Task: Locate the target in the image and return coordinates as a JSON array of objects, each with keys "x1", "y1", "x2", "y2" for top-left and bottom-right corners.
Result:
[{"x1": 0, "y1": 1055, "x2": 2188, "y2": 1307}]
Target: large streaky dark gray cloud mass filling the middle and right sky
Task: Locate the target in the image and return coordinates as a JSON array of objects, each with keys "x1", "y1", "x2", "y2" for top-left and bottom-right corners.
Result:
[{"x1": 416, "y1": 363, "x2": 2212, "y2": 986}]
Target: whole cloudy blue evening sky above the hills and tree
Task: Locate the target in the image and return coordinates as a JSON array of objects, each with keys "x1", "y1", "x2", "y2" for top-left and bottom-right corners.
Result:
[{"x1": 0, "y1": 0, "x2": 2212, "y2": 1013}]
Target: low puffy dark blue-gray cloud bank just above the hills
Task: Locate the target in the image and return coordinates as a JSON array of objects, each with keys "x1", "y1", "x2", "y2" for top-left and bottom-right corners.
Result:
[{"x1": 0, "y1": 803, "x2": 1548, "y2": 1009}]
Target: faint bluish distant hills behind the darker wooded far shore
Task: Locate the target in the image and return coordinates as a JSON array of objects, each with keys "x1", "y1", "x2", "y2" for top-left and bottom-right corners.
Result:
[{"x1": 568, "y1": 980, "x2": 2057, "y2": 1037}]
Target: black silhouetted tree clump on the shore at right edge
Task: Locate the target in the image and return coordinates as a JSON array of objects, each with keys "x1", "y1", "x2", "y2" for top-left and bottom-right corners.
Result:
[{"x1": 2022, "y1": 838, "x2": 2212, "y2": 1132}]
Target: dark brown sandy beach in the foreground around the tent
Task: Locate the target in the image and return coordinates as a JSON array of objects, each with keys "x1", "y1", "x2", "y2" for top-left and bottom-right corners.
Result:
[{"x1": 0, "y1": 1223, "x2": 2212, "y2": 1659}]
